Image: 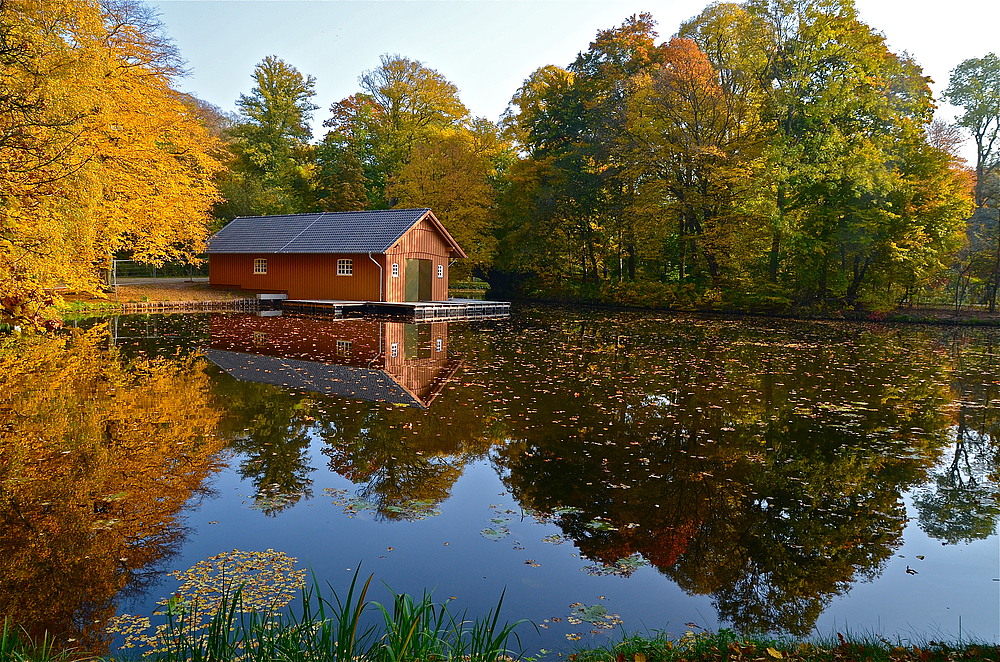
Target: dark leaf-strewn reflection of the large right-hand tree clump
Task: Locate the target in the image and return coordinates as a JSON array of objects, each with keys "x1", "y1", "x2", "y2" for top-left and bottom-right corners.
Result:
[{"x1": 488, "y1": 321, "x2": 980, "y2": 635}]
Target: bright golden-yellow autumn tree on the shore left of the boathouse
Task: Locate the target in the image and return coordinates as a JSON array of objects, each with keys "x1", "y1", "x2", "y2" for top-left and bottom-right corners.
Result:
[{"x1": 0, "y1": 0, "x2": 220, "y2": 325}]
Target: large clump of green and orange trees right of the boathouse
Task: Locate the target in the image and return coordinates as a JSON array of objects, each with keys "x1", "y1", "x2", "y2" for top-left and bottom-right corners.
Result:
[{"x1": 496, "y1": 0, "x2": 970, "y2": 309}]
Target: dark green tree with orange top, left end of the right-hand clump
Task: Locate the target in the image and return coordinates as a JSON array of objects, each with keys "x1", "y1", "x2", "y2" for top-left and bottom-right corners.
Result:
[{"x1": 498, "y1": 14, "x2": 659, "y2": 289}]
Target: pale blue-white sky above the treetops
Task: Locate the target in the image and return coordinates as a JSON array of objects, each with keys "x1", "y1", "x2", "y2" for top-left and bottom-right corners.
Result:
[{"x1": 148, "y1": 0, "x2": 1000, "y2": 152}]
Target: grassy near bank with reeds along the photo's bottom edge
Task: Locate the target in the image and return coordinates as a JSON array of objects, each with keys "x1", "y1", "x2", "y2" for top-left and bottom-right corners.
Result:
[{"x1": 0, "y1": 588, "x2": 1000, "y2": 662}]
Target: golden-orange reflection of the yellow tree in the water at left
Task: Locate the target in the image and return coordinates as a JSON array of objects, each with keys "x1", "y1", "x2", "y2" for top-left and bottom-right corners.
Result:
[{"x1": 0, "y1": 329, "x2": 225, "y2": 654}]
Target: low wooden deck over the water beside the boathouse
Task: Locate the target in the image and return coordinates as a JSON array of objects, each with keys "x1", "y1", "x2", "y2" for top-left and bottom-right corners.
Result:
[{"x1": 281, "y1": 299, "x2": 510, "y2": 321}]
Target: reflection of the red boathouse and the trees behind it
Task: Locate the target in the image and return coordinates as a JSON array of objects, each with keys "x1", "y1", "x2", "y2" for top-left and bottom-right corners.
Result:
[{"x1": 206, "y1": 316, "x2": 497, "y2": 519}]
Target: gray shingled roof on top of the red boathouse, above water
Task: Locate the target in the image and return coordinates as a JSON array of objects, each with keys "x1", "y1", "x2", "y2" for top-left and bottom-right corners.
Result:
[{"x1": 208, "y1": 209, "x2": 430, "y2": 253}]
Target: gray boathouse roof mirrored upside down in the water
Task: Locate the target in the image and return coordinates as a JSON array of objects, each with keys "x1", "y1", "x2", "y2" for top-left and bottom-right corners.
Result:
[{"x1": 202, "y1": 349, "x2": 426, "y2": 409}]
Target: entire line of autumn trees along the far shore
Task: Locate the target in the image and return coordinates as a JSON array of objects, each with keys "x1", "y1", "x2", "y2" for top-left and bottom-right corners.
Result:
[{"x1": 0, "y1": 0, "x2": 1000, "y2": 325}]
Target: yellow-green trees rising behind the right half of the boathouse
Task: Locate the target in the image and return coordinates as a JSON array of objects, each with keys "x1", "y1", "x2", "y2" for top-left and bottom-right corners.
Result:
[{"x1": 317, "y1": 55, "x2": 511, "y2": 278}]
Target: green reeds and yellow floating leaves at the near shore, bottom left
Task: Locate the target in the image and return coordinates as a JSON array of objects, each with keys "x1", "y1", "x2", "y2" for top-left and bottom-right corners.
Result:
[{"x1": 126, "y1": 572, "x2": 522, "y2": 662}]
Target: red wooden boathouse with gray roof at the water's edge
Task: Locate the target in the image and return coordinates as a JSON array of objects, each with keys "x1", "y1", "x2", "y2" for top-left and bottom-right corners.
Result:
[{"x1": 208, "y1": 209, "x2": 466, "y2": 302}]
